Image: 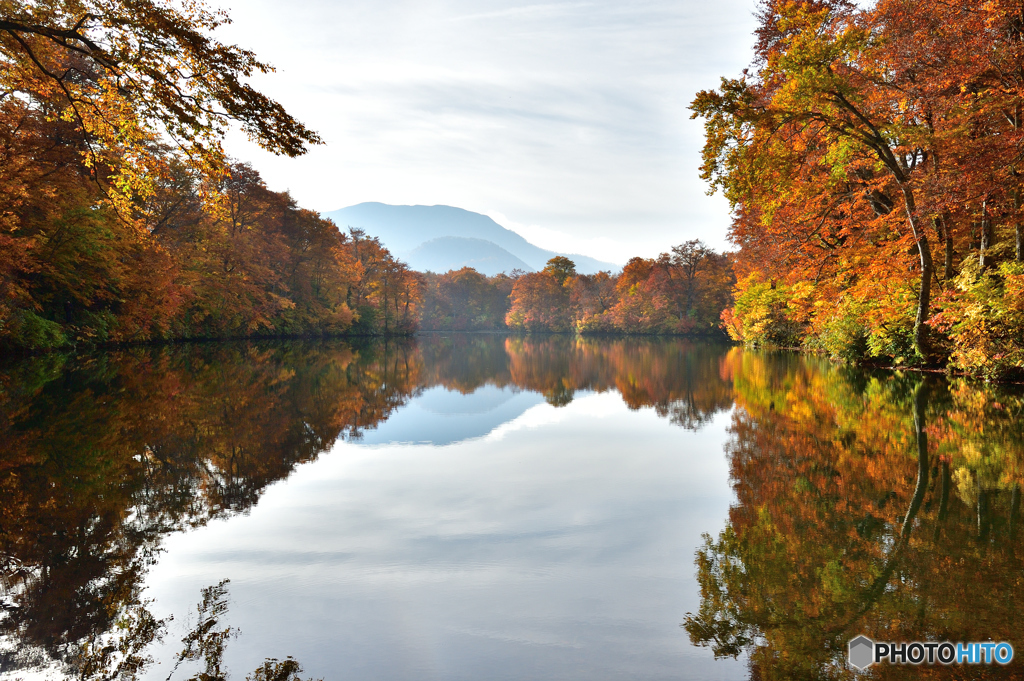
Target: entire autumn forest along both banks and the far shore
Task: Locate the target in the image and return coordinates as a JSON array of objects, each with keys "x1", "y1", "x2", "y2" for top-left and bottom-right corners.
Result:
[{"x1": 0, "y1": 0, "x2": 1024, "y2": 379}]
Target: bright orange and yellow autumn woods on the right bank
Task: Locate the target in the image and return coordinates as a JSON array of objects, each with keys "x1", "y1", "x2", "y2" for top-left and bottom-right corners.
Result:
[{"x1": 691, "y1": 0, "x2": 1024, "y2": 378}]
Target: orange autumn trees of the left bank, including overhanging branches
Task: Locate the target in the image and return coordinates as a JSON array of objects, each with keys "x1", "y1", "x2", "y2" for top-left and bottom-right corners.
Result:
[{"x1": 0, "y1": 0, "x2": 399, "y2": 349}]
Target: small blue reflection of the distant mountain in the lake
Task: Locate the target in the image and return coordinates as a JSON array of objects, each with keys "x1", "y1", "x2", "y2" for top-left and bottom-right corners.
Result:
[{"x1": 360, "y1": 385, "x2": 544, "y2": 444}]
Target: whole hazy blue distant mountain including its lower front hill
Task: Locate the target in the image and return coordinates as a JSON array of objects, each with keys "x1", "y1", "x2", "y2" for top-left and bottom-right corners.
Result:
[{"x1": 324, "y1": 203, "x2": 618, "y2": 275}]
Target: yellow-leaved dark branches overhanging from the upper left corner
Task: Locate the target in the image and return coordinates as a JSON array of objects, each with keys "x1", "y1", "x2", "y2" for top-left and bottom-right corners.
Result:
[{"x1": 0, "y1": 0, "x2": 319, "y2": 210}]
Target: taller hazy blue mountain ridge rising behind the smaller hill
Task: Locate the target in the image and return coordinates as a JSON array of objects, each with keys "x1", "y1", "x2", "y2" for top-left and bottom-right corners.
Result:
[{"x1": 324, "y1": 203, "x2": 618, "y2": 273}]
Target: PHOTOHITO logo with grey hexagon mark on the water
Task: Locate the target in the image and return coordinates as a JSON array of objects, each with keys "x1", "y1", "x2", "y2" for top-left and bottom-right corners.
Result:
[{"x1": 849, "y1": 636, "x2": 1014, "y2": 670}]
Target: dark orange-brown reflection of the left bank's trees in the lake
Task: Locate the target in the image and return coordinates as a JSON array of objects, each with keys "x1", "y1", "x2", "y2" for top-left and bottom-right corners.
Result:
[{"x1": 0, "y1": 343, "x2": 419, "y2": 671}]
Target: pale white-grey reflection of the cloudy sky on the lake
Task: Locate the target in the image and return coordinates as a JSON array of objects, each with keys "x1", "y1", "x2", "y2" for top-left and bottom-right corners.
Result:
[{"x1": 142, "y1": 391, "x2": 745, "y2": 679}]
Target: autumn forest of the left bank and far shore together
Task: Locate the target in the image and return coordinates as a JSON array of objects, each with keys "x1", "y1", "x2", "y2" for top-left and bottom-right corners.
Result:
[{"x1": 0, "y1": 0, "x2": 733, "y2": 350}]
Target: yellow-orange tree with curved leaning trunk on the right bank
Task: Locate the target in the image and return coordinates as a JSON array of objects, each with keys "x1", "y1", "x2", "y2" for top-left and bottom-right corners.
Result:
[{"x1": 692, "y1": 2, "x2": 933, "y2": 358}]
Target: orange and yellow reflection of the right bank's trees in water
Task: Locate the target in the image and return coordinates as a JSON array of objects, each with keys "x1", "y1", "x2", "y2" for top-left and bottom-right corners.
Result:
[{"x1": 686, "y1": 350, "x2": 1024, "y2": 679}]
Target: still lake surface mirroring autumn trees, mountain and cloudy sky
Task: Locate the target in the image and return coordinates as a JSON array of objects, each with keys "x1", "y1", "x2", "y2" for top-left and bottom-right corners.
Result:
[{"x1": 0, "y1": 335, "x2": 1024, "y2": 680}]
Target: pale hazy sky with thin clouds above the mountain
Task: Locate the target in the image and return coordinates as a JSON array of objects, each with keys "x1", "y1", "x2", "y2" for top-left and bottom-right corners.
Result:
[{"x1": 221, "y1": 0, "x2": 755, "y2": 263}]
